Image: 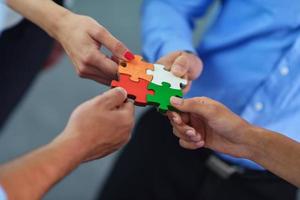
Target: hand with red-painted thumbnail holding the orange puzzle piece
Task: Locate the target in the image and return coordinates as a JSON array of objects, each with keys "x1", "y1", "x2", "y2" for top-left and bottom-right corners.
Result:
[{"x1": 52, "y1": 12, "x2": 134, "y2": 85}]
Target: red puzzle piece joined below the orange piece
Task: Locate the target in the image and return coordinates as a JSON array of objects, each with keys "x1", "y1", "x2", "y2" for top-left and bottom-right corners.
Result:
[{"x1": 111, "y1": 74, "x2": 154, "y2": 106}]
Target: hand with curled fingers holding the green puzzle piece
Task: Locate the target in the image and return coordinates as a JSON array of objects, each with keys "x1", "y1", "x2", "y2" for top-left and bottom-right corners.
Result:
[{"x1": 168, "y1": 97, "x2": 253, "y2": 157}]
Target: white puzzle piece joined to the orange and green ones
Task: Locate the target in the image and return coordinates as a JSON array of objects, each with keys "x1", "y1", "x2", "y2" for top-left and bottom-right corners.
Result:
[{"x1": 147, "y1": 64, "x2": 187, "y2": 90}]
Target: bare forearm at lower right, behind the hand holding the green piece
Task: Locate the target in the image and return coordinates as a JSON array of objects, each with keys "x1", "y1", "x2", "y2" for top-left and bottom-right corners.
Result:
[{"x1": 246, "y1": 128, "x2": 300, "y2": 187}]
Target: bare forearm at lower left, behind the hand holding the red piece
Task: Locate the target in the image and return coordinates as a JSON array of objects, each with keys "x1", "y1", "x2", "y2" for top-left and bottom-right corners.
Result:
[{"x1": 0, "y1": 135, "x2": 84, "y2": 200}]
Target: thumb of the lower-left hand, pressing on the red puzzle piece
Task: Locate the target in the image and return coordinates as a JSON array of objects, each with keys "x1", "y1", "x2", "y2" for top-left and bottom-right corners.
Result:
[{"x1": 99, "y1": 87, "x2": 127, "y2": 109}]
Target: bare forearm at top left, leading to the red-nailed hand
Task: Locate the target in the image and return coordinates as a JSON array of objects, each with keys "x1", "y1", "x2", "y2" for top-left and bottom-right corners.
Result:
[{"x1": 6, "y1": 0, "x2": 70, "y2": 37}]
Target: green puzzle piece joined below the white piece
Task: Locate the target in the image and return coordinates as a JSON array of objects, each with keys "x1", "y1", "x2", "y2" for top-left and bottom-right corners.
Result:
[{"x1": 147, "y1": 82, "x2": 183, "y2": 113}]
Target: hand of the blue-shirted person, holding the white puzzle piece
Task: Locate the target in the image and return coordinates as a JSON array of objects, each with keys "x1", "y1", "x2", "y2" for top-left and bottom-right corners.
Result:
[{"x1": 157, "y1": 51, "x2": 203, "y2": 93}]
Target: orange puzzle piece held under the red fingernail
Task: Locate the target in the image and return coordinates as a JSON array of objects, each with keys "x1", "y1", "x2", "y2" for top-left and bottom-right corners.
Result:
[{"x1": 119, "y1": 55, "x2": 154, "y2": 82}]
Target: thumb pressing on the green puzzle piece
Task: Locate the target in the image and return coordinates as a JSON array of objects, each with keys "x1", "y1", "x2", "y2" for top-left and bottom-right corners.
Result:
[{"x1": 171, "y1": 97, "x2": 216, "y2": 118}]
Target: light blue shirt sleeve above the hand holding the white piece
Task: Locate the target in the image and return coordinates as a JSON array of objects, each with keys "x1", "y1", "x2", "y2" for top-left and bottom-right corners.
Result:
[{"x1": 141, "y1": 0, "x2": 213, "y2": 62}]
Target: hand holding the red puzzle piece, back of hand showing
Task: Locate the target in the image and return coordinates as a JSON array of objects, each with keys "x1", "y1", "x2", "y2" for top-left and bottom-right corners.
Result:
[{"x1": 54, "y1": 88, "x2": 134, "y2": 161}]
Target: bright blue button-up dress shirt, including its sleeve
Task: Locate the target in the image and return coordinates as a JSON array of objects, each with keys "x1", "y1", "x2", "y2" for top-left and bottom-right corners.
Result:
[{"x1": 142, "y1": 0, "x2": 300, "y2": 169}]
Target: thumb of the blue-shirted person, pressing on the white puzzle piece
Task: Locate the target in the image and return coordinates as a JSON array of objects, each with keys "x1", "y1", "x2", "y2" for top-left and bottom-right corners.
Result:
[{"x1": 171, "y1": 54, "x2": 189, "y2": 77}]
